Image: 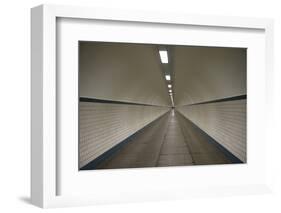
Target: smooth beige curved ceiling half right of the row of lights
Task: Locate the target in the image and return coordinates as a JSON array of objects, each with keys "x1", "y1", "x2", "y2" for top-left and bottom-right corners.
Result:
[{"x1": 173, "y1": 46, "x2": 246, "y2": 106}]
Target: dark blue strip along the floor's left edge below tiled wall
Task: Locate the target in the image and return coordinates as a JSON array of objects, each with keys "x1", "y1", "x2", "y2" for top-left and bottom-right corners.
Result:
[{"x1": 79, "y1": 111, "x2": 169, "y2": 170}]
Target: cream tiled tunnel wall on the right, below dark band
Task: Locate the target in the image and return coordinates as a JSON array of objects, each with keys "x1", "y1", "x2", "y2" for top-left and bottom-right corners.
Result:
[{"x1": 177, "y1": 99, "x2": 247, "y2": 162}]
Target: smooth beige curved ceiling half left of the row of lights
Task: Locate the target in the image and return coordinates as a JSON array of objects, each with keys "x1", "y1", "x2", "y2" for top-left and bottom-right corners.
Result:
[{"x1": 79, "y1": 42, "x2": 171, "y2": 106}]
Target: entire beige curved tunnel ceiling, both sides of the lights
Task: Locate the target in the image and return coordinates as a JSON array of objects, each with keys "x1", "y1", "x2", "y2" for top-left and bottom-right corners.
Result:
[{"x1": 79, "y1": 42, "x2": 246, "y2": 106}]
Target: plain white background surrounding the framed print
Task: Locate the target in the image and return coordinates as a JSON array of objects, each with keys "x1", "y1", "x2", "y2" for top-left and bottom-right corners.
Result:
[{"x1": 0, "y1": 0, "x2": 281, "y2": 213}]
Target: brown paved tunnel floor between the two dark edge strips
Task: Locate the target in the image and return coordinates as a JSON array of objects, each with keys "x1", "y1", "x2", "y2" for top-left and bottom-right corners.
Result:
[{"x1": 97, "y1": 110, "x2": 231, "y2": 169}]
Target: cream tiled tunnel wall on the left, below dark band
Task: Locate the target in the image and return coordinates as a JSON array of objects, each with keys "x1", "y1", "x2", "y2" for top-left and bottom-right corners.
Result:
[{"x1": 79, "y1": 102, "x2": 169, "y2": 168}]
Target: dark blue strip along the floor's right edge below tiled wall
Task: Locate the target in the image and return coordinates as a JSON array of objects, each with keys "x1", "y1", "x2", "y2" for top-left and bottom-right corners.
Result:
[{"x1": 177, "y1": 111, "x2": 244, "y2": 163}]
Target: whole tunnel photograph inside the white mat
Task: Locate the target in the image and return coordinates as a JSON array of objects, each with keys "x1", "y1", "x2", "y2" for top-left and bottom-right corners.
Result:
[{"x1": 78, "y1": 41, "x2": 247, "y2": 170}]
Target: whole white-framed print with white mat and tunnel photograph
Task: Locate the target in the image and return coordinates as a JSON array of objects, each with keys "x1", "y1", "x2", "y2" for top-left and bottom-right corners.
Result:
[{"x1": 31, "y1": 5, "x2": 273, "y2": 207}]
